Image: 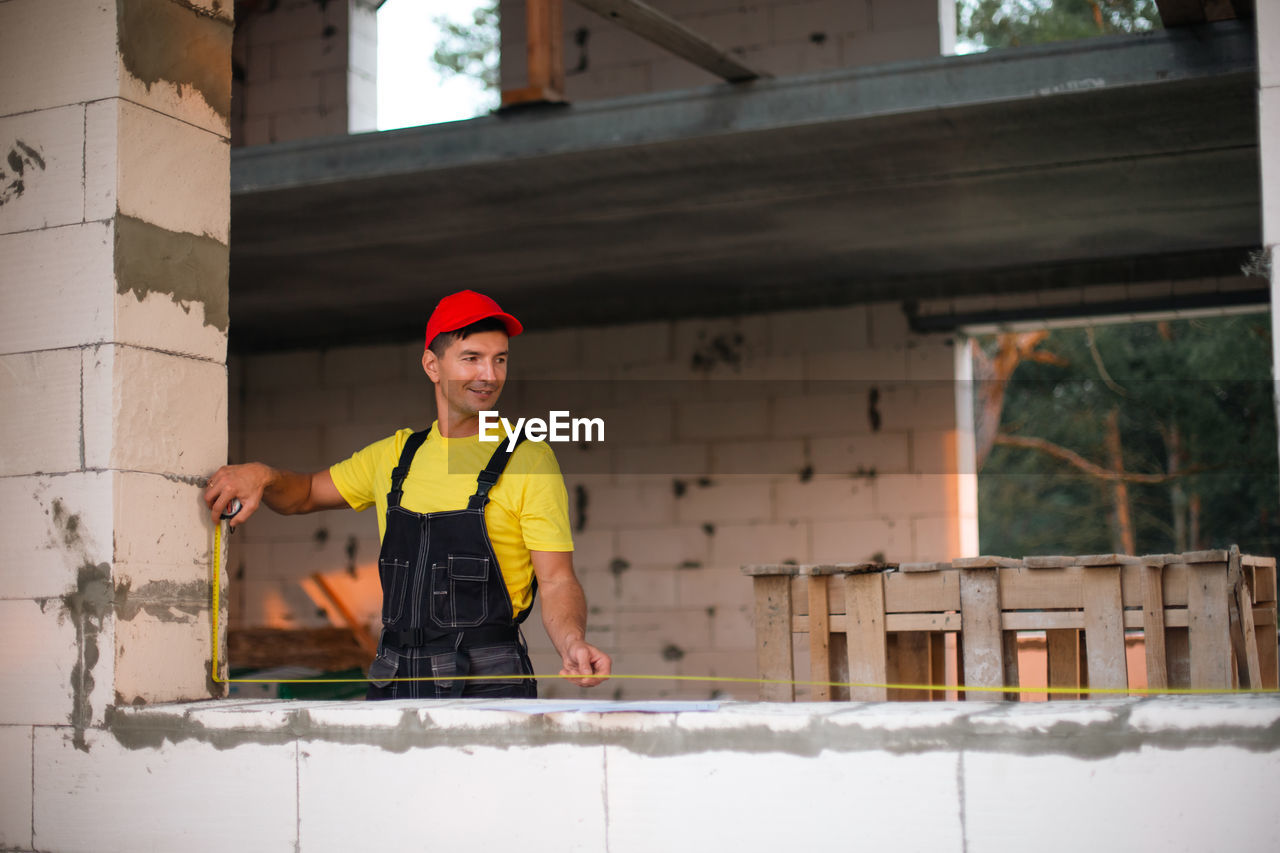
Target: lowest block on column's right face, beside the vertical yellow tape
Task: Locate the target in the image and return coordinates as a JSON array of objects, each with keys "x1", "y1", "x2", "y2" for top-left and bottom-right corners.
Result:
[{"x1": 115, "y1": 601, "x2": 212, "y2": 704}]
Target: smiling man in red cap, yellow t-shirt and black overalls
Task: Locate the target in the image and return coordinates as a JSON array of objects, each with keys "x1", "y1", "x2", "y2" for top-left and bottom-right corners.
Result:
[{"x1": 205, "y1": 291, "x2": 612, "y2": 699}]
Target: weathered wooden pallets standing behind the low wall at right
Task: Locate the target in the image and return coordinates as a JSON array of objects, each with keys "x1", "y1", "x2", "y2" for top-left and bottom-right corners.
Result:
[{"x1": 742, "y1": 547, "x2": 1280, "y2": 702}]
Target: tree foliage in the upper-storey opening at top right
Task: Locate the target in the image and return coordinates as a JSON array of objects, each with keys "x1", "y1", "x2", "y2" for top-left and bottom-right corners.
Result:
[{"x1": 956, "y1": 0, "x2": 1161, "y2": 50}]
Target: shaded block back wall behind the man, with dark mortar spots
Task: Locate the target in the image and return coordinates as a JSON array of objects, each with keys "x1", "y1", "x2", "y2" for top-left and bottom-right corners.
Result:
[{"x1": 232, "y1": 298, "x2": 975, "y2": 698}]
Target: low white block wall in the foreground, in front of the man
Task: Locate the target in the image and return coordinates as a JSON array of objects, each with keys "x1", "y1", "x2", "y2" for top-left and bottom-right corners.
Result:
[{"x1": 12, "y1": 695, "x2": 1280, "y2": 853}]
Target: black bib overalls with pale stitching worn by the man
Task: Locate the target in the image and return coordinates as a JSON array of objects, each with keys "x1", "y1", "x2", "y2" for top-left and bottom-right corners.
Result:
[{"x1": 367, "y1": 430, "x2": 538, "y2": 699}]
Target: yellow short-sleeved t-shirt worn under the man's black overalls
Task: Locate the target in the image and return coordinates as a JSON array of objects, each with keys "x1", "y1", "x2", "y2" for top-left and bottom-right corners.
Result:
[{"x1": 329, "y1": 423, "x2": 573, "y2": 613}]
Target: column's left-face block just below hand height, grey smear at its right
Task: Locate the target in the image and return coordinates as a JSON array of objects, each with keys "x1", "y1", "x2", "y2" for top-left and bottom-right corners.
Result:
[{"x1": 0, "y1": 474, "x2": 113, "y2": 598}]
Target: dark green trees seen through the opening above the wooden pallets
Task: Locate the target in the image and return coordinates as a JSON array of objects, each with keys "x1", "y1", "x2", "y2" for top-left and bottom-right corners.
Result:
[{"x1": 978, "y1": 314, "x2": 1280, "y2": 556}]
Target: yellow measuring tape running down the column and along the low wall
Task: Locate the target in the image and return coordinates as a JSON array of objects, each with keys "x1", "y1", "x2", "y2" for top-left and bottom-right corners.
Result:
[{"x1": 212, "y1": 523, "x2": 1276, "y2": 695}]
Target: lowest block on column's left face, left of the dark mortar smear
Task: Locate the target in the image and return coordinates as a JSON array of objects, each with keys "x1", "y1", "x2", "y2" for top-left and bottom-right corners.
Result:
[{"x1": 0, "y1": 598, "x2": 77, "y2": 725}]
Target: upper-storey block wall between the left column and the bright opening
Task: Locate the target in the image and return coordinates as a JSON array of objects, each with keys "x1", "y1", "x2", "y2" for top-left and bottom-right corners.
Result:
[{"x1": 232, "y1": 0, "x2": 376, "y2": 145}]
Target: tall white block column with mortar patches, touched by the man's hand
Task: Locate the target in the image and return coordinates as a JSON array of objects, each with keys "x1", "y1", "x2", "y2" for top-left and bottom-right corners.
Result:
[{"x1": 0, "y1": 0, "x2": 232, "y2": 783}]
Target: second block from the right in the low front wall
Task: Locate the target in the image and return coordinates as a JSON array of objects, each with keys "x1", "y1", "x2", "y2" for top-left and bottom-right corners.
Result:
[{"x1": 607, "y1": 747, "x2": 962, "y2": 853}]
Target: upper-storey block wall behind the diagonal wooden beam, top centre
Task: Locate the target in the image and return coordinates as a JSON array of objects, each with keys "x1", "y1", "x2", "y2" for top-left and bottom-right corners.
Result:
[{"x1": 499, "y1": 0, "x2": 955, "y2": 101}]
